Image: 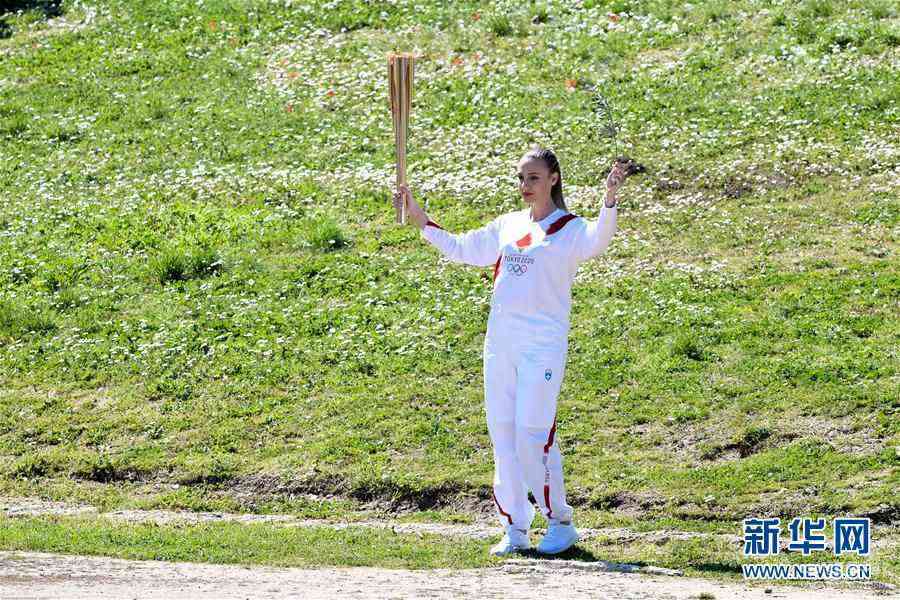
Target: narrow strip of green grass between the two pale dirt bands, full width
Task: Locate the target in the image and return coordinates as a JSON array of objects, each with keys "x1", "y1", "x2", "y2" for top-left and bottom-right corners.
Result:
[{"x1": 0, "y1": 517, "x2": 897, "y2": 581}]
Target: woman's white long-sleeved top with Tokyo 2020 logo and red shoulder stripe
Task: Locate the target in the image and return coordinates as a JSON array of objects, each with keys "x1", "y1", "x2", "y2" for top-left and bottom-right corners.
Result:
[{"x1": 422, "y1": 205, "x2": 616, "y2": 347}]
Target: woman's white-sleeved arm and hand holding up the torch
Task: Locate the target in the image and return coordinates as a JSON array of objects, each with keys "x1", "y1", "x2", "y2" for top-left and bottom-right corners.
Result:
[{"x1": 394, "y1": 185, "x2": 500, "y2": 267}]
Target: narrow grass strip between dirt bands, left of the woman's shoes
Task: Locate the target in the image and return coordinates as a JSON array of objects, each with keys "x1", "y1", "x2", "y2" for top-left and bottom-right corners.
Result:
[{"x1": 0, "y1": 517, "x2": 500, "y2": 569}]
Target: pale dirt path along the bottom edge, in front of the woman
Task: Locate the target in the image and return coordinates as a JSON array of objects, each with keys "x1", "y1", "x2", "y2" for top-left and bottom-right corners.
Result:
[{"x1": 0, "y1": 552, "x2": 897, "y2": 600}]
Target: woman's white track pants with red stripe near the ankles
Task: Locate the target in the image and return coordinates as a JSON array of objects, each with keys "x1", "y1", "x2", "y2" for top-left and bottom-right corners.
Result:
[{"x1": 484, "y1": 338, "x2": 572, "y2": 529}]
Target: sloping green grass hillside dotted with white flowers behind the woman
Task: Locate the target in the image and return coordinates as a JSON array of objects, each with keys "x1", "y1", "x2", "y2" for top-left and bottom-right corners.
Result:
[{"x1": 0, "y1": 0, "x2": 900, "y2": 582}]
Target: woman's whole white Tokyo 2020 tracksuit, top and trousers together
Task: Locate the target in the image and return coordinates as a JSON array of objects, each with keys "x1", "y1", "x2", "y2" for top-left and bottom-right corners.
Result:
[{"x1": 422, "y1": 206, "x2": 616, "y2": 529}]
